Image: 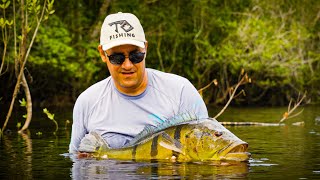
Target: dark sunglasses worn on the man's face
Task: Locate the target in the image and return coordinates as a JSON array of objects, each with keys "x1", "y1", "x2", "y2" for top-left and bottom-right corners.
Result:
[{"x1": 104, "y1": 51, "x2": 145, "y2": 65}]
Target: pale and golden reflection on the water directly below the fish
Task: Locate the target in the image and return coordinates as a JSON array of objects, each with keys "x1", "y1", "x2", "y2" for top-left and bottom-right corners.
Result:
[{"x1": 72, "y1": 159, "x2": 249, "y2": 179}]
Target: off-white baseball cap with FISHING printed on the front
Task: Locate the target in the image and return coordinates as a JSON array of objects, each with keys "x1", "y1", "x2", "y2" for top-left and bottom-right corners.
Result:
[{"x1": 100, "y1": 12, "x2": 146, "y2": 51}]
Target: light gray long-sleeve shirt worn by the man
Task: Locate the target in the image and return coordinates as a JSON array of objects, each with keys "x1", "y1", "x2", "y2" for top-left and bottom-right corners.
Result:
[{"x1": 69, "y1": 68, "x2": 208, "y2": 153}]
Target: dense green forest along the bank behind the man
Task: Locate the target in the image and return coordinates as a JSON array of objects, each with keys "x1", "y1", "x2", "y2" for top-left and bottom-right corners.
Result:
[{"x1": 0, "y1": 0, "x2": 320, "y2": 109}]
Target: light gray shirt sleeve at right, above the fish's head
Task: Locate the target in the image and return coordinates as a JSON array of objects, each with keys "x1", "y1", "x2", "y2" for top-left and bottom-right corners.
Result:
[{"x1": 179, "y1": 80, "x2": 209, "y2": 119}]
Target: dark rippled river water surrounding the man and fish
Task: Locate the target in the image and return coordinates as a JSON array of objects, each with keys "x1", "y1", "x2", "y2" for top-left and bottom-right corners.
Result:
[{"x1": 0, "y1": 106, "x2": 320, "y2": 179}]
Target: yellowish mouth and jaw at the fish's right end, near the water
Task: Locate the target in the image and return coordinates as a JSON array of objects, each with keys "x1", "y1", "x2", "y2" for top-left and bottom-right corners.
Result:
[{"x1": 221, "y1": 143, "x2": 251, "y2": 161}]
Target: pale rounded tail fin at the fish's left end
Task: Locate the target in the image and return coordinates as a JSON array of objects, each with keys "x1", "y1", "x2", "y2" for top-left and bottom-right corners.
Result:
[{"x1": 78, "y1": 131, "x2": 109, "y2": 152}]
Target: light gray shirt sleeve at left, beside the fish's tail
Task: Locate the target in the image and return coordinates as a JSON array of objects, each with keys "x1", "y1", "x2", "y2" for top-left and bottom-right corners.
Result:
[{"x1": 69, "y1": 95, "x2": 87, "y2": 153}]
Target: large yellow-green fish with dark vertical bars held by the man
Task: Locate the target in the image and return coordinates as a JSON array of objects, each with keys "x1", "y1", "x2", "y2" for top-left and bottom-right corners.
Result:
[{"x1": 79, "y1": 118, "x2": 250, "y2": 162}]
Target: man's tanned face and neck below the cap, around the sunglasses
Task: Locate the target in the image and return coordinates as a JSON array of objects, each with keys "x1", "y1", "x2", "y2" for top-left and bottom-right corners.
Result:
[{"x1": 99, "y1": 43, "x2": 147, "y2": 95}]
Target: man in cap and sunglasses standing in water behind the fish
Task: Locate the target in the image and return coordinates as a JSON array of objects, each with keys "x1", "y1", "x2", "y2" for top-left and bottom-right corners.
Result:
[{"x1": 69, "y1": 13, "x2": 208, "y2": 153}]
